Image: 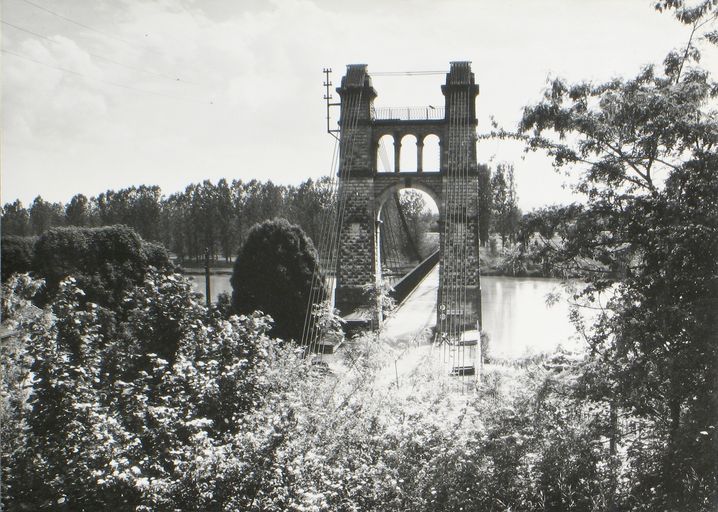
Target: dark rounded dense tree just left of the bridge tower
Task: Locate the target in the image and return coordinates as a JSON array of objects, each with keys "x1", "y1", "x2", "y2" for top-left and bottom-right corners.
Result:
[{"x1": 231, "y1": 219, "x2": 319, "y2": 340}]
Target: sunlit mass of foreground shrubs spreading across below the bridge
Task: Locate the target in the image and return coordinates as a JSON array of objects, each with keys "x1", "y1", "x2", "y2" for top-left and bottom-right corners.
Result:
[{"x1": 0, "y1": 262, "x2": 698, "y2": 512}]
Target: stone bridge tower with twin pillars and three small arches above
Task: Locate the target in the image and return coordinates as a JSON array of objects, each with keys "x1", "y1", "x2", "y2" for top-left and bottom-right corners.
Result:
[{"x1": 335, "y1": 62, "x2": 481, "y2": 328}]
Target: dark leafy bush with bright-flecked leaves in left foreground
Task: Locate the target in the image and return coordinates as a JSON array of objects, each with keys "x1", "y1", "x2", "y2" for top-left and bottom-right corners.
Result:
[{"x1": 0, "y1": 274, "x2": 284, "y2": 510}]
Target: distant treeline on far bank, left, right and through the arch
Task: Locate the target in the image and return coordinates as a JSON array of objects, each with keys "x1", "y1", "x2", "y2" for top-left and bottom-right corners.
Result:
[{"x1": 2, "y1": 164, "x2": 521, "y2": 263}]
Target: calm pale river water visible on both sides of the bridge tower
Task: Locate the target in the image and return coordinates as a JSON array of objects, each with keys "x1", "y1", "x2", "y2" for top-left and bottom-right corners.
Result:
[{"x1": 189, "y1": 274, "x2": 582, "y2": 357}]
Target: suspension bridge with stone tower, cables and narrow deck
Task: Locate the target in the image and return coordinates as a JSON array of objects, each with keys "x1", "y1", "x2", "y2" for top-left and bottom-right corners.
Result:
[{"x1": 302, "y1": 62, "x2": 481, "y2": 386}]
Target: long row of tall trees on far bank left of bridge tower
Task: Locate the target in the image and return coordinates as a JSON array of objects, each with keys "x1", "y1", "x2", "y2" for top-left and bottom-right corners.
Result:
[{"x1": 2, "y1": 177, "x2": 332, "y2": 262}]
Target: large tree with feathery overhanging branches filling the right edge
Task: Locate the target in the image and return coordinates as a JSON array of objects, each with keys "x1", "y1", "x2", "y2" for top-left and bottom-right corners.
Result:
[{"x1": 520, "y1": 0, "x2": 718, "y2": 511}]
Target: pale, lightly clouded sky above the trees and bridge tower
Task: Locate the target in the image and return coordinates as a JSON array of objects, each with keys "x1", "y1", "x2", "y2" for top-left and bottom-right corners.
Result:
[{"x1": 0, "y1": 0, "x2": 718, "y2": 211}]
